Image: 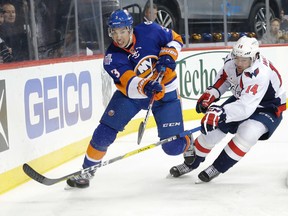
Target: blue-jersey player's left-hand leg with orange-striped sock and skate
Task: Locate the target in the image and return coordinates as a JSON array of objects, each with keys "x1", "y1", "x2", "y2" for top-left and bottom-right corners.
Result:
[{"x1": 67, "y1": 91, "x2": 142, "y2": 187}]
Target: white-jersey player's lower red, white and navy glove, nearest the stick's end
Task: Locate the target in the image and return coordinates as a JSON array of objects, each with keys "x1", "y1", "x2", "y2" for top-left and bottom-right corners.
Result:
[{"x1": 201, "y1": 105, "x2": 226, "y2": 134}]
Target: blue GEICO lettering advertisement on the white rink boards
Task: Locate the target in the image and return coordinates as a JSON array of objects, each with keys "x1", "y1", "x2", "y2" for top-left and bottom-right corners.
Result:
[{"x1": 24, "y1": 70, "x2": 96, "y2": 139}]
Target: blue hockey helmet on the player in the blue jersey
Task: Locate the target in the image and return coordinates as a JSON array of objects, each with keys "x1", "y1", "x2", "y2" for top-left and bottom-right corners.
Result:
[{"x1": 108, "y1": 9, "x2": 133, "y2": 29}]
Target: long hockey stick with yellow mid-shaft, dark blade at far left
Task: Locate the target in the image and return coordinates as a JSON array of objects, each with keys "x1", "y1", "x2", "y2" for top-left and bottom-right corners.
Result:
[{"x1": 23, "y1": 126, "x2": 201, "y2": 185}]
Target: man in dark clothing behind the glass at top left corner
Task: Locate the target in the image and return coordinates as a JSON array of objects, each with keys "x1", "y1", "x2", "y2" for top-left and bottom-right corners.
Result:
[{"x1": 0, "y1": 3, "x2": 29, "y2": 61}]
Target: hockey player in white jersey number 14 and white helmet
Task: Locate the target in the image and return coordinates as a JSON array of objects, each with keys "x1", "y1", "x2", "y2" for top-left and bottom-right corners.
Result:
[{"x1": 170, "y1": 37, "x2": 286, "y2": 182}]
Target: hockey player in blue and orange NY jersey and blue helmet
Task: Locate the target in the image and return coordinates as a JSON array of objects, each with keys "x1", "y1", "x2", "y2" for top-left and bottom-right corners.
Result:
[{"x1": 67, "y1": 9, "x2": 190, "y2": 187}]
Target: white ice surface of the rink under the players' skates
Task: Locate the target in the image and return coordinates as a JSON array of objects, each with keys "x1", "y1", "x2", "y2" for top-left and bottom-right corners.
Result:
[{"x1": 0, "y1": 122, "x2": 288, "y2": 216}]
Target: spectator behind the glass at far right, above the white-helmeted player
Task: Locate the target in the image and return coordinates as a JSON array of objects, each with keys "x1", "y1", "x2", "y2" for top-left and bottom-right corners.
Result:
[{"x1": 261, "y1": 18, "x2": 286, "y2": 44}]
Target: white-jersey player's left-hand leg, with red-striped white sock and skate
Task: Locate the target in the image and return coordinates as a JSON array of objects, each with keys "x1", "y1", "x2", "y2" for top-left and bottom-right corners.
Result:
[{"x1": 170, "y1": 129, "x2": 226, "y2": 177}]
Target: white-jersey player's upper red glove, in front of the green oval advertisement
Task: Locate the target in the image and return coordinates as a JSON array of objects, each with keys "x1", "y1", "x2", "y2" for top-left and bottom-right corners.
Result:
[{"x1": 196, "y1": 86, "x2": 220, "y2": 113}]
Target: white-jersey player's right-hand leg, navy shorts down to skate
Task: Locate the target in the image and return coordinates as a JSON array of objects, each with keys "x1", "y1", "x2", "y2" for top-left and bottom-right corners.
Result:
[{"x1": 198, "y1": 110, "x2": 282, "y2": 182}]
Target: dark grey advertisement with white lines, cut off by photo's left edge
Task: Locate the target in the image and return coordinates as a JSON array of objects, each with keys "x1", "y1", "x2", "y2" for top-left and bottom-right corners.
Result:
[{"x1": 0, "y1": 80, "x2": 9, "y2": 152}]
